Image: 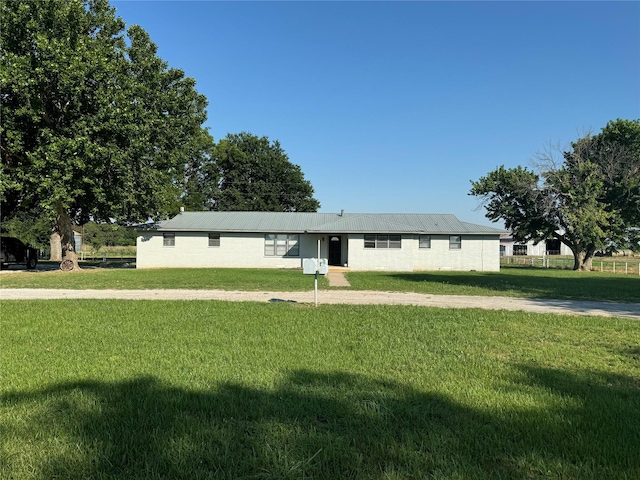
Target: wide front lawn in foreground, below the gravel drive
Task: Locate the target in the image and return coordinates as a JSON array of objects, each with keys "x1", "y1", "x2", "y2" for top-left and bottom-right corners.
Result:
[{"x1": 0, "y1": 302, "x2": 640, "y2": 480}]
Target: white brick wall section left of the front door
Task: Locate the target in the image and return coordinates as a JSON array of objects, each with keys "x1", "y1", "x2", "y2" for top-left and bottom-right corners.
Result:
[{"x1": 136, "y1": 231, "x2": 319, "y2": 268}]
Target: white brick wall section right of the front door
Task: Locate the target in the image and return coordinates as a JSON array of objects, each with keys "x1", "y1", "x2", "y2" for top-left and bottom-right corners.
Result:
[{"x1": 349, "y1": 235, "x2": 500, "y2": 272}]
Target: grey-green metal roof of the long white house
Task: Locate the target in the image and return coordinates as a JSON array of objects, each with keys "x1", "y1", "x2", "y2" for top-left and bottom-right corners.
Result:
[{"x1": 158, "y1": 212, "x2": 504, "y2": 235}]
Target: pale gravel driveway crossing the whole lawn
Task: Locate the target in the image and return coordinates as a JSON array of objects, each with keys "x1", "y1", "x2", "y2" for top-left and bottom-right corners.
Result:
[{"x1": 0, "y1": 288, "x2": 640, "y2": 319}]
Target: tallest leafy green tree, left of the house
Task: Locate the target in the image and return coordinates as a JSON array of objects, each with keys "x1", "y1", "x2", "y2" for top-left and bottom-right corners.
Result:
[{"x1": 0, "y1": 0, "x2": 212, "y2": 268}]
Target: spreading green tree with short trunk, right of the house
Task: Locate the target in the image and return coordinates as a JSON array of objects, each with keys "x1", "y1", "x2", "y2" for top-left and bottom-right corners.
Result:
[{"x1": 470, "y1": 120, "x2": 640, "y2": 270}]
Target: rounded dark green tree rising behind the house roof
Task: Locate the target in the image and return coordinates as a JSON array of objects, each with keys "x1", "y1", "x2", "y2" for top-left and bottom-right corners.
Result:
[{"x1": 185, "y1": 132, "x2": 320, "y2": 212}]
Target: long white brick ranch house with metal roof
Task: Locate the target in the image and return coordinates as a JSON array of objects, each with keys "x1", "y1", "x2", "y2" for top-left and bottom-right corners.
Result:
[{"x1": 136, "y1": 212, "x2": 504, "y2": 271}]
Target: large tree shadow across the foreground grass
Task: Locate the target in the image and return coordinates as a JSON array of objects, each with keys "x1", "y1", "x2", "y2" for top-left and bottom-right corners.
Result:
[{"x1": 0, "y1": 367, "x2": 640, "y2": 479}]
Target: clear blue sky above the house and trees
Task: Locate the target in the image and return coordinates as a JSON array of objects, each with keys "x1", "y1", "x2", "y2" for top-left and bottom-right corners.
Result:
[{"x1": 112, "y1": 0, "x2": 640, "y2": 226}]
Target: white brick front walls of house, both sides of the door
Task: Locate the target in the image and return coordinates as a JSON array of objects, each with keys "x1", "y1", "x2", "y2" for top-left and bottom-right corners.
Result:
[{"x1": 136, "y1": 231, "x2": 500, "y2": 272}]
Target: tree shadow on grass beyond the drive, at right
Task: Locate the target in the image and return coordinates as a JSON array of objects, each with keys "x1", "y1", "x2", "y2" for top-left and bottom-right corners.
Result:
[{"x1": 384, "y1": 269, "x2": 640, "y2": 302}]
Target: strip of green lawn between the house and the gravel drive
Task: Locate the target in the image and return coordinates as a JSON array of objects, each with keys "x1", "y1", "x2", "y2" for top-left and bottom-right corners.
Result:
[{"x1": 0, "y1": 267, "x2": 640, "y2": 302}]
